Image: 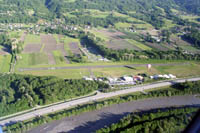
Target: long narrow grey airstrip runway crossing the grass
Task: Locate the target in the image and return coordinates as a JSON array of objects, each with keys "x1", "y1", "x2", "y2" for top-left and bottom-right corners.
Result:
[{"x1": 18, "y1": 63, "x2": 189, "y2": 72}]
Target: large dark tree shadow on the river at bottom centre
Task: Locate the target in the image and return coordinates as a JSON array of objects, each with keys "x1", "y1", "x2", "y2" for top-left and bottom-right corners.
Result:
[{"x1": 59, "y1": 112, "x2": 129, "y2": 133}]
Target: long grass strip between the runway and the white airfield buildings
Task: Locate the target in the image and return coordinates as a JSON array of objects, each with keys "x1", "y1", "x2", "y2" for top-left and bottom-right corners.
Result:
[{"x1": 15, "y1": 62, "x2": 200, "y2": 79}]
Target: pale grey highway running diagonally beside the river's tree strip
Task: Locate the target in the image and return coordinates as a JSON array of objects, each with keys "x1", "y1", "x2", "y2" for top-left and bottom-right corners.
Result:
[{"x1": 0, "y1": 77, "x2": 200, "y2": 125}]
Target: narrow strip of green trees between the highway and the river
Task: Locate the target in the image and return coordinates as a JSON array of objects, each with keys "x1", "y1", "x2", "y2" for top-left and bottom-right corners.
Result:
[{"x1": 4, "y1": 81, "x2": 200, "y2": 133}]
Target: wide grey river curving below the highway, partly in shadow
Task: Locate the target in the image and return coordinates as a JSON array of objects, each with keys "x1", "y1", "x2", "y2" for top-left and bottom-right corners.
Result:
[{"x1": 28, "y1": 95, "x2": 200, "y2": 133}]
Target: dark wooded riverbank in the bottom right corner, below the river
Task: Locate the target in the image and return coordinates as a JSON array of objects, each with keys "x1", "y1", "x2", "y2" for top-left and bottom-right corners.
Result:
[{"x1": 96, "y1": 107, "x2": 199, "y2": 133}]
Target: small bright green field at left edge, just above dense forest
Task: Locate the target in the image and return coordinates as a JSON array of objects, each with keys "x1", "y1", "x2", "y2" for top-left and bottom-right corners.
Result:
[{"x1": 0, "y1": 55, "x2": 12, "y2": 72}]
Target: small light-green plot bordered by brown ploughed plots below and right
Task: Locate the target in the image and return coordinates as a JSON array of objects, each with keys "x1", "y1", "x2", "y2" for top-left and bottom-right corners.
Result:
[{"x1": 24, "y1": 34, "x2": 41, "y2": 45}]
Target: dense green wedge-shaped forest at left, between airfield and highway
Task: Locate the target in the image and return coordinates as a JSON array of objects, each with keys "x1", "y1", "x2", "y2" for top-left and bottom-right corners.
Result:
[{"x1": 0, "y1": 74, "x2": 109, "y2": 116}]
